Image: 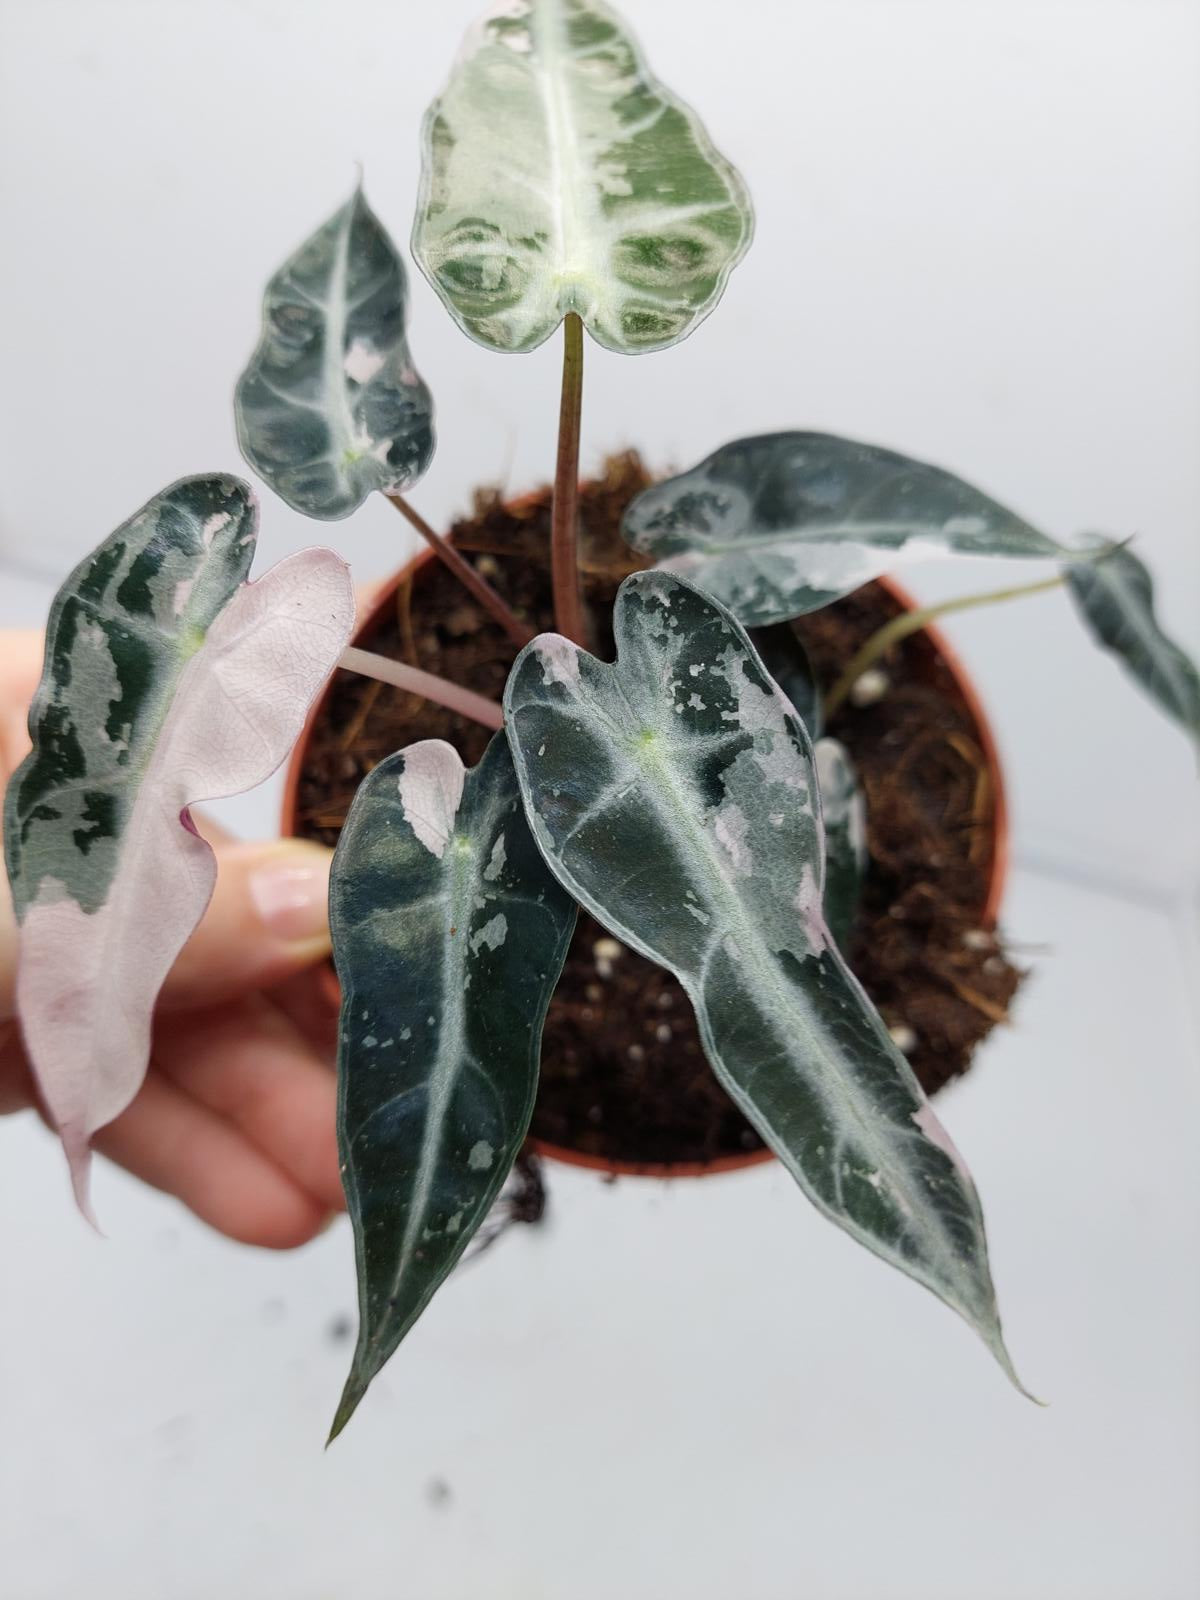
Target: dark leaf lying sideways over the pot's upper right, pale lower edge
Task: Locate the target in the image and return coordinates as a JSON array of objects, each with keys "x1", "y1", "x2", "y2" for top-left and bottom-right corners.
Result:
[{"x1": 624, "y1": 434, "x2": 1064, "y2": 627}]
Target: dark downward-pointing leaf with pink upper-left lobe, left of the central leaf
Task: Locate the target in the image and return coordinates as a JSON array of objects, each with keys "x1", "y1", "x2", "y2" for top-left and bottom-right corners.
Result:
[{"x1": 330, "y1": 733, "x2": 576, "y2": 1435}]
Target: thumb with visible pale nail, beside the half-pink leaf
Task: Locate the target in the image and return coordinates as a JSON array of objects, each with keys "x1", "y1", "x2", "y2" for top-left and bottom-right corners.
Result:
[{"x1": 163, "y1": 829, "x2": 333, "y2": 1008}]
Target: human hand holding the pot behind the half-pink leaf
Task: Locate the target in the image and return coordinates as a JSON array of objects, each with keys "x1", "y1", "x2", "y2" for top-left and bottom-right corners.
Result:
[{"x1": 0, "y1": 630, "x2": 344, "y2": 1250}]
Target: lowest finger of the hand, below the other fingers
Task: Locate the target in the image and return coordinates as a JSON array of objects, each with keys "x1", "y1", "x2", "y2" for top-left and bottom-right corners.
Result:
[{"x1": 93, "y1": 1072, "x2": 330, "y2": 1250}]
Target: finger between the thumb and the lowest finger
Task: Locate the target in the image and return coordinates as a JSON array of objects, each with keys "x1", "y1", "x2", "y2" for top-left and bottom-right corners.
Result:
[{"x1": 155, "y1": 995, "x2": 342, "y2": 1211}]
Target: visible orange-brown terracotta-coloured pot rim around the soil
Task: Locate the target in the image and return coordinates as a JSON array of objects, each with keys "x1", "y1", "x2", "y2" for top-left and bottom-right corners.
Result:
[{"x1": 282, "y1": 518, "x2": 1008, "y2": 1178}]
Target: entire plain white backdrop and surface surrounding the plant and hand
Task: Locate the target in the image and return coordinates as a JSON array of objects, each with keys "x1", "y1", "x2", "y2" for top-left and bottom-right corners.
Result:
[{"x1": 0, "y1": 0, "x2": 1200, "y2": 1600}]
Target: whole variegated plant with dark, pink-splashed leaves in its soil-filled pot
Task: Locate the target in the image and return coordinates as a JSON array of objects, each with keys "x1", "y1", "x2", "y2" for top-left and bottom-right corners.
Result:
[{"x1": 5, "y1": 0, "x2": 1200, "y2": 1452}]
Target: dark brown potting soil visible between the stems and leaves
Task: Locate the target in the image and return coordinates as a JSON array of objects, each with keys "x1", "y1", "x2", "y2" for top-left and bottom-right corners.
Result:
[{"x1": 296, "y1": 456, "x2": 1019, "y2": 1163}]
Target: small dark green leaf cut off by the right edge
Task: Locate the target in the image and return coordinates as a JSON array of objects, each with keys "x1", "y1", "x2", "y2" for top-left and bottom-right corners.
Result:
[{"x1": 1066, "y1": 546, "x2": 1200, "y2": 741}]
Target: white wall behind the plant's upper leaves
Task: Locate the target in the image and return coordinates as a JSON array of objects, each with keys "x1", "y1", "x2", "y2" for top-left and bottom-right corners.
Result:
[{"x1": 0, "y1": 0, "x2": 1200, "y2": 894}]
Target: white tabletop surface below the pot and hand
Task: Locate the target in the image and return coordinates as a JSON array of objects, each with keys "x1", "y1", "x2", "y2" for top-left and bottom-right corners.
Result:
[{"x1": 0, "y1": 875, "x2": 1200, "y2": 1600}]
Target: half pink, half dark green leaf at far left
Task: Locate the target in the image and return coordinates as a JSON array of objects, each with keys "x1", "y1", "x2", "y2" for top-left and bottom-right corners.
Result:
[{"x1": 5, "y1": 477, "x2": 354, "y2": 1210}]
